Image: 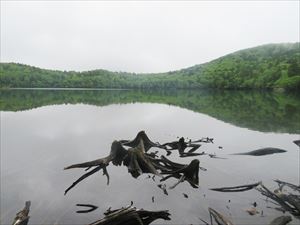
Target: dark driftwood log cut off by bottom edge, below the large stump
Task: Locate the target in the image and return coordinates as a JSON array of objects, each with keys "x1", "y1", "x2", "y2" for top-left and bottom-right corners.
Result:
[{"x1": 89, "y1": 206, "x2": 170, "y2": 225}]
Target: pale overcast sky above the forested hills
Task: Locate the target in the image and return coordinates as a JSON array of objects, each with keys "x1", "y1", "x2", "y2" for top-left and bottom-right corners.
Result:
[{"x1": 1, "y1": 1, "x2": 300, "y2": 72}]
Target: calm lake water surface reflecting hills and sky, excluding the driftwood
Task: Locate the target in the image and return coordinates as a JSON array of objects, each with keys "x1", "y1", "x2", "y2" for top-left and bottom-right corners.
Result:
[{"x1": 0, "y1": 90, "x2": 300, "y2": 225}]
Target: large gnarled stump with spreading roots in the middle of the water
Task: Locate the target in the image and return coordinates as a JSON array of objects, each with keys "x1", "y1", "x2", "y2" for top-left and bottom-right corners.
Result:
[{"x1": 64, "y1": 132, "x2": 200, "y2": 194}]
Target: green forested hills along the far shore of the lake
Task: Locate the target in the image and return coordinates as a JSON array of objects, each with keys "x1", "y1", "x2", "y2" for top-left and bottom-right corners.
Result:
[{"x1": 0, "y1": 42, "x2": 300, "y2": 90}]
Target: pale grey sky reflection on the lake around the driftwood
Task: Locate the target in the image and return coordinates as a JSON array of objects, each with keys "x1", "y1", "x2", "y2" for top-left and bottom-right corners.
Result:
[{"x1": 1, "y1": 103, "x2": 299, "y2": 224}]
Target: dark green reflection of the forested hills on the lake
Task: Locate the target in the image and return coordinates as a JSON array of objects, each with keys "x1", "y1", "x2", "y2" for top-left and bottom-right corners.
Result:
[{"x1": 0, "y1": 90, "x2": 300, "y2": 133}]
